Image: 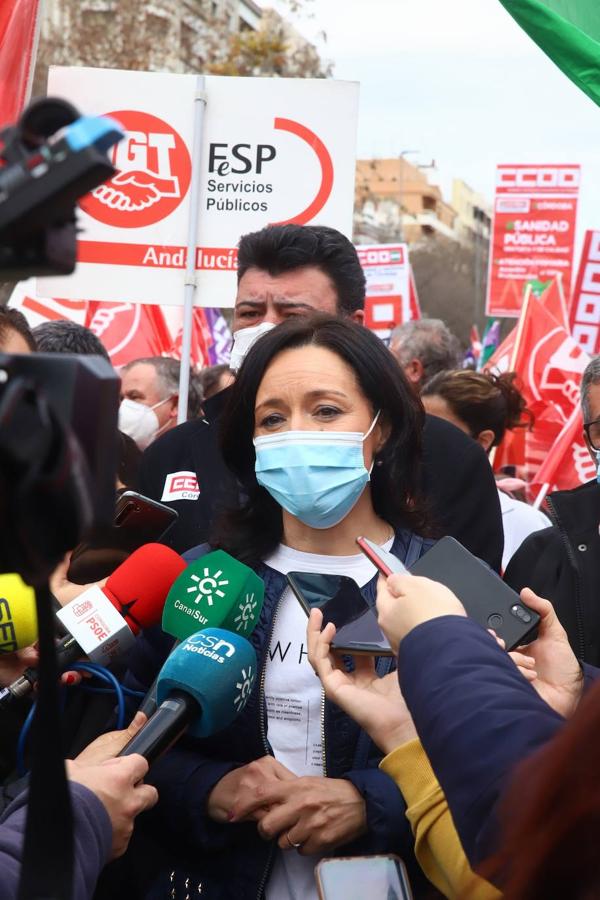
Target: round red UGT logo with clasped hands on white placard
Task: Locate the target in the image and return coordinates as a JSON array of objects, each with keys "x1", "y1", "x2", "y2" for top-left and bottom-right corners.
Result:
[{"x1": 80, "y1": 110, "x2": 192, "y2": 228}]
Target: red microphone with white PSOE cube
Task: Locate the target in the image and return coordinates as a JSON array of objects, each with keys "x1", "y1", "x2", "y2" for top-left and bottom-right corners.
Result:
[{"x1": 0, "y1": 544, "x2": 185, "y2": 709}]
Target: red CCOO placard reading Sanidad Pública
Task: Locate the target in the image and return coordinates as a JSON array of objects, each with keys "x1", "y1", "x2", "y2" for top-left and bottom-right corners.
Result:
[{"x1": 486, "y1": 165, "x2": 580, "y2": 317}]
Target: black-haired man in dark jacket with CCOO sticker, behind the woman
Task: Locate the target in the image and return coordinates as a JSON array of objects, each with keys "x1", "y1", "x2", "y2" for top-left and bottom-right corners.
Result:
[{"x1": 138, "y1": 225, "x2": 504, "y2": 571}]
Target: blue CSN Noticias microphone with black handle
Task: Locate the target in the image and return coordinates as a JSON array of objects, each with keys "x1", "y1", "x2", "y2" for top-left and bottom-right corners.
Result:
[{"x1": 119, "y1": 628, "x2": 257, "y2": 764}]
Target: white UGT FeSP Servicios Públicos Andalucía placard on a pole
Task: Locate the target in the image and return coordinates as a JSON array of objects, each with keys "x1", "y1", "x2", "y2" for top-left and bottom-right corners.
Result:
[{"x1": 38, "y1": 67, "x2": 358, "y2": 307}]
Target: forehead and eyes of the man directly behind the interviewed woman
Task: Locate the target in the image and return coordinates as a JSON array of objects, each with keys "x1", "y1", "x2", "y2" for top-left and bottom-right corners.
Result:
[{"x1": 233, "y1": 266, "x2": 363, "y2": 331}]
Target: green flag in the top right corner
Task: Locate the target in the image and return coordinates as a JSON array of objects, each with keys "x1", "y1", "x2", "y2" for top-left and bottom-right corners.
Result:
[{"x1": 500, "y1": 0, "x2": 600, "y2": 106}]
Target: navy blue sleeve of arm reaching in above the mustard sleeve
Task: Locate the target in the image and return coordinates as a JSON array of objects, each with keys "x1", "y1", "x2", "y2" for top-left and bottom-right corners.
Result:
[{"x1": 398, "y1": 616, "x2": 600, "y2": 866}]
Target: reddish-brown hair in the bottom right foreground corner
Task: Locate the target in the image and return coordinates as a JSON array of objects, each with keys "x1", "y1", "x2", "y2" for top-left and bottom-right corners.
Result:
[{"x1": 482, "y1": 683, "x2": 600, "y2": 900}]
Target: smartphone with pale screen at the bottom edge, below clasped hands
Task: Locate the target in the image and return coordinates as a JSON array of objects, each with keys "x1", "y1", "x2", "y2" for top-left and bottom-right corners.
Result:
[{"x1": 315, "y1": 853, "x2": 412, "y2": 900}]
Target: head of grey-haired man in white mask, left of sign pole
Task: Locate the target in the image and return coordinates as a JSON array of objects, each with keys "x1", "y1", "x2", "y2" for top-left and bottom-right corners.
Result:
[{"x1": 119, "y1": 356, "x2": 202, "y2": 450}]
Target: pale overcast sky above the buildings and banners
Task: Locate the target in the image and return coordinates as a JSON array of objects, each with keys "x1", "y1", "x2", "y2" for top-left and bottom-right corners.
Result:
[{"x1": 270, "y1": 0, "x2": 600, "y2": 258}]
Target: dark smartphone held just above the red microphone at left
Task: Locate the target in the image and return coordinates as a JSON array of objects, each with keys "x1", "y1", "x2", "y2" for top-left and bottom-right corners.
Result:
[{"x1": 67, "y1": 491, "x2": 178, "y2": 584}]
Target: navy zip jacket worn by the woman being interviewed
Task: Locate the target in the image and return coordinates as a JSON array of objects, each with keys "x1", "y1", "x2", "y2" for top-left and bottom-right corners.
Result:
[{"x1": 120, "y1": 531, "x2": 432, "y2": 900}]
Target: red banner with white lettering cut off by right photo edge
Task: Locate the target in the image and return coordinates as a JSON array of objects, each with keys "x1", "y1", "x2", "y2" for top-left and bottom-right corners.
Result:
[{"x1": 570, "y1": 231, "x2": 600, "y2": 356}]
